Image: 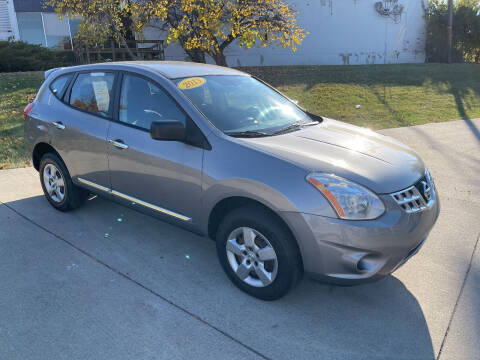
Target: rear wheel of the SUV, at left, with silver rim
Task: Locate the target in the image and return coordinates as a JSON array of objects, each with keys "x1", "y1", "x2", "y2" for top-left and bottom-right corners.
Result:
[{"x1": 39, "y1": 153, "x2": 88, "y2": 211}]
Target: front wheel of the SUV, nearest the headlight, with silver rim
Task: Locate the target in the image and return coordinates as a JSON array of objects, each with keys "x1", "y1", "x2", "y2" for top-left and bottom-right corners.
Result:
[{"x1": 216, "y1": 206, "x2": 302, "y2": 300}]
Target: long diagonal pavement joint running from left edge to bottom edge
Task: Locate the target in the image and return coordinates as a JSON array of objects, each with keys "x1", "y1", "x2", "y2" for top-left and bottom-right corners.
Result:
[{"x1": 0, "y1": 201, "x2": 270, "y2": 360}]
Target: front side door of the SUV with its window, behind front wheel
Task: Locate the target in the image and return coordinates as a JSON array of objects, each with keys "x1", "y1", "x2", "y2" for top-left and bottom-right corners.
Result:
[{"x1": 107, "y1": 73, "x2": 204, "y2": 227}]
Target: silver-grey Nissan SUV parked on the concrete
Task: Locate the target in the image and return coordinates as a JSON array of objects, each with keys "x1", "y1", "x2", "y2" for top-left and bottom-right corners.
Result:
[{"x1": 24, "y1": 62, "x2": 440, "y2": 300}]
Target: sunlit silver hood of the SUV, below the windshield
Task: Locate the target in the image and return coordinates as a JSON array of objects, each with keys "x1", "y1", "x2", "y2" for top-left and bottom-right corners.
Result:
[{"x1": 242, "y1": 119, "x2": 425, "y2": 194}]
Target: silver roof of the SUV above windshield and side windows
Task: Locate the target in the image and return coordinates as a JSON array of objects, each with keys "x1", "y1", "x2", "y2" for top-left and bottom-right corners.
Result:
[{"x1": 49, "y1": 61, "x2": 247, "y2": 79}]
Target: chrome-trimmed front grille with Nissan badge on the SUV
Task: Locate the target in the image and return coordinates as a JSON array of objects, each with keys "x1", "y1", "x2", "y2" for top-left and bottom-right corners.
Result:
[{"x1": 392, "y1": 170, "x2": 435, "y2": 214}]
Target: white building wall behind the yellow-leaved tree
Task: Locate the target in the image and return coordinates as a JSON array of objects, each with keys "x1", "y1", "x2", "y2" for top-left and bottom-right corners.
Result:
[{"x1": 152, "y1": 0, "x2": 426, "y2": 66}]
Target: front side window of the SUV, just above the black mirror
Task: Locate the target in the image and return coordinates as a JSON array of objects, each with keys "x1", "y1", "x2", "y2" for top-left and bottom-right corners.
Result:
[{"x1": 119, "y1": 74, "x2": 187, "y2": 130}]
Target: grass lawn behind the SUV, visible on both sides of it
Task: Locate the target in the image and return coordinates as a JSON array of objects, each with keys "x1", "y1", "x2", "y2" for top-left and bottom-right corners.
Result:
[{"x1": 0, "y1": 64, "x2": 480, "y2": 168}]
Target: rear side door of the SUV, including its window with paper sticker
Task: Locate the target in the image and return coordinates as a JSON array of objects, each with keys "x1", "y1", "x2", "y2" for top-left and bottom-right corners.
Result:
[{"x1": 51, "y1": 71, "x2": 116, "y2": 190}]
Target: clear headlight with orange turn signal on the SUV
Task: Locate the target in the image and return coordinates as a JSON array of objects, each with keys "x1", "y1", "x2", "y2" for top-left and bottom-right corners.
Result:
[{"x1": 307, "y1": 173, "x2": 385, "y2": 220}]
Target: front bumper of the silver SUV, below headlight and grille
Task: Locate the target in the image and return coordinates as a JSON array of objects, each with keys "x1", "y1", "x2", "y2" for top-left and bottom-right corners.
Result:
[{"x1": 284, "y1": 190, "x2": 440, "y2": 285}]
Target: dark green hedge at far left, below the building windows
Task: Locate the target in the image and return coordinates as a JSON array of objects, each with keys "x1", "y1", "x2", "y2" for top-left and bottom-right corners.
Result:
[{"x1": 0, "y1": 41, "x2": 75, "y2": 72}]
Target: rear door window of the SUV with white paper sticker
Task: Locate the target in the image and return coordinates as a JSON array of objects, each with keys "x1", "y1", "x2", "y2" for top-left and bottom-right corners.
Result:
[{"x1": 70, "y1": 72, "x2": 115, "y2": 116}]
